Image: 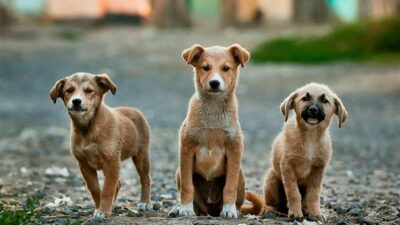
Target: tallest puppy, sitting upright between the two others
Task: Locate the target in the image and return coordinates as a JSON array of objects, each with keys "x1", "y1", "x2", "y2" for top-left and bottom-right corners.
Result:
[{"x1": 172, "y1": 44, "x2": 250, "y2": 217}]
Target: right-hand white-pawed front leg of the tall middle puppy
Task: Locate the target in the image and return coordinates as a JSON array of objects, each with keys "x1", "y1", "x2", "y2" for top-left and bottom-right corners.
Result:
[{"x1": 221, "y1": 139, "x2": 243, "y2": 218}]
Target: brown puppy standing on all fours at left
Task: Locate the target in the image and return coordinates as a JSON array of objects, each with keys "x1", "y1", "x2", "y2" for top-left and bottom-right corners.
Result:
[{"x1": 50, "y1": 73, "x2": 151, "y2": 218}]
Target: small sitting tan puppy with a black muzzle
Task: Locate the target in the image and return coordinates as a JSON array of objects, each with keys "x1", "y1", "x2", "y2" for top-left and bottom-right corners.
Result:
[{"x1": 242, "y1": 83, "x2": 347, "y2": 221}]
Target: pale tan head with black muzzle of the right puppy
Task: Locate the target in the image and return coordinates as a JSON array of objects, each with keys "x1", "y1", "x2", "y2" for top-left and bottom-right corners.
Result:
[{"x1": 281, "y1": 83, "x2": 347, "y2": 127}]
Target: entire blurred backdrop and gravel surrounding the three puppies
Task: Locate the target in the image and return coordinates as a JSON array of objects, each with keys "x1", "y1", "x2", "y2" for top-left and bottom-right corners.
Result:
[{"x1": 0, "y1": 0, "x2": 400, "y2": 224}]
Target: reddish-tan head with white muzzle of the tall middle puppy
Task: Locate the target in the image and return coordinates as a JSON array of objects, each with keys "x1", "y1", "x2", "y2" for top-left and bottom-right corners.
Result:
[{"x1": 182, "y1": 44, "x2": 250, "y2": 95}]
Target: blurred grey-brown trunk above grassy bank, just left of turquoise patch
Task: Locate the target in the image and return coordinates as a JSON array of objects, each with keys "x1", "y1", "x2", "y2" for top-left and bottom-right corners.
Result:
[{"x1": 294, "y1": 0, "x2": 330, "y2": 23}]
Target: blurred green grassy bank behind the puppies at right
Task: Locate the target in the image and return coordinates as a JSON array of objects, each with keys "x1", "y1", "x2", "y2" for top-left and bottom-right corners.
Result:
[{"x1": 252, "y1": 17, "x2": 400, "y2": 63}]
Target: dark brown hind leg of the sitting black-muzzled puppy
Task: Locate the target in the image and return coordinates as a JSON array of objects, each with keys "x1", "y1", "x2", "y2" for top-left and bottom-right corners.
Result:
[{"x1": 264, "y1": 168, "x2": 286, "y2": 212}]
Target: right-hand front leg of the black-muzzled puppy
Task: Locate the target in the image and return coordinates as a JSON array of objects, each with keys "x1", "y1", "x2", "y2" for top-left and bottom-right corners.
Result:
[{"x1": 305, "y1": 166, "x2": 324, "y2": 221}]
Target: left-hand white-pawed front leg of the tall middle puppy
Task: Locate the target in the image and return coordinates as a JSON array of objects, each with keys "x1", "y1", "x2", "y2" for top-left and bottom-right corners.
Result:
[{"x1": 179, "y1": 141, "x2": 196, "y2": 216}]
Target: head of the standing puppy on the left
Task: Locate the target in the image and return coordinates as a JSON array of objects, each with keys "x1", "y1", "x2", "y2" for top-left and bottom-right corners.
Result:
[{"x1": 50, "y1": 73, "x2": 117, "y2": 117}]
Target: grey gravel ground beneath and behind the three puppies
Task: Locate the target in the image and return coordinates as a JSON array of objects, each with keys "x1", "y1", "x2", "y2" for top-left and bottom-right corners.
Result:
[{"x1": 0, "y1": 27, "x2": 400, "y2": 225}]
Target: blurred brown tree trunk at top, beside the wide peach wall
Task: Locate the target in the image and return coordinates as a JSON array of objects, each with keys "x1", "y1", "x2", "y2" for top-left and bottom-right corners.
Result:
[{"x1": 151, "y1": 0, "x2": 191, "y2": 27}]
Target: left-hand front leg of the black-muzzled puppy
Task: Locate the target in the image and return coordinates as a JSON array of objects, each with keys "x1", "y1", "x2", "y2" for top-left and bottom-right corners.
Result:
[{"x1": 281, "y1": 161, "x2": 303, "y2": 218}]
